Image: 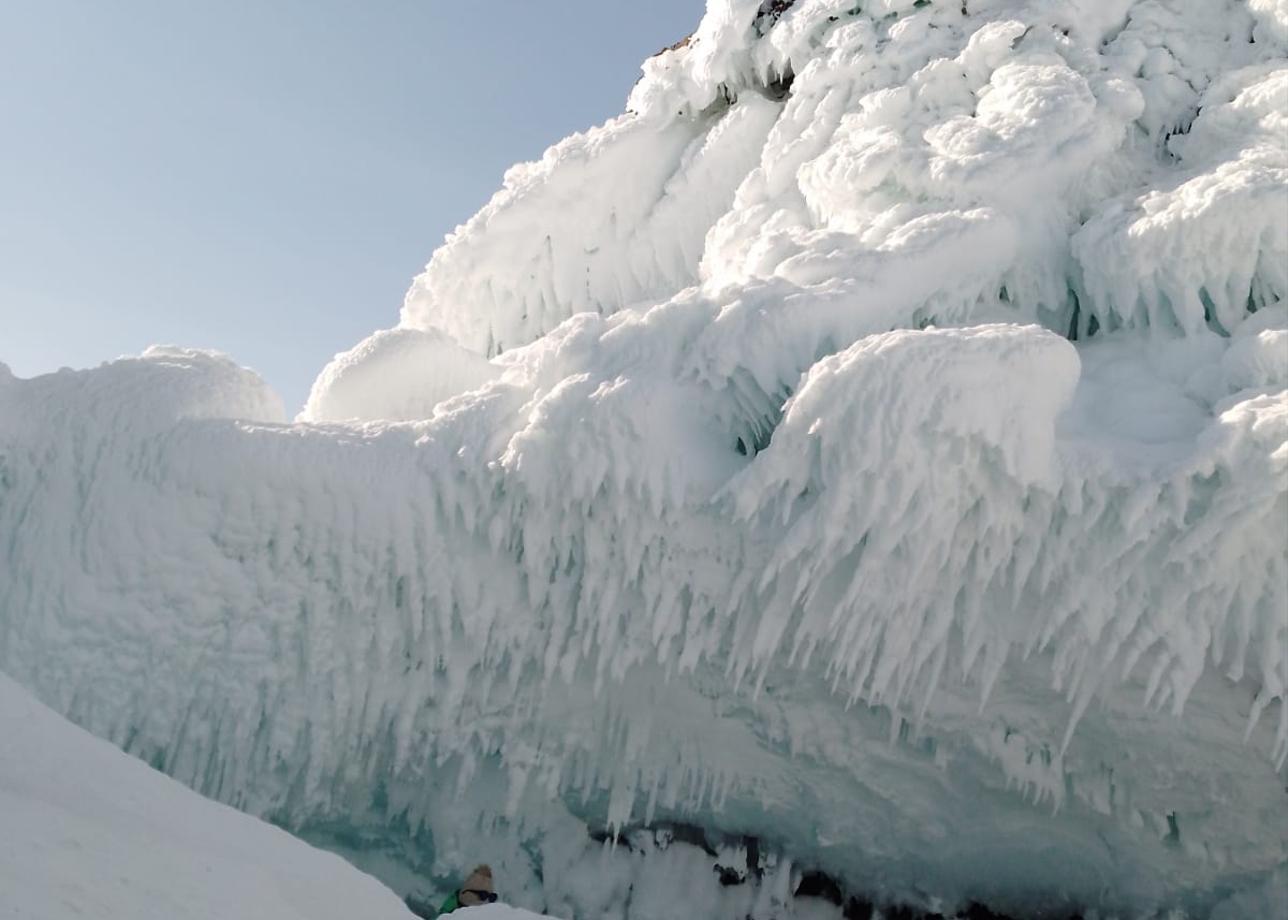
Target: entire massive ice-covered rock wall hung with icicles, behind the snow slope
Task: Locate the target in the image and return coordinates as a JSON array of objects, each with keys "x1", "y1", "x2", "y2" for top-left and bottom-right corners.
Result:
[{"x1": 0, "y1": 0, "x2": 1288, "y2": 920}]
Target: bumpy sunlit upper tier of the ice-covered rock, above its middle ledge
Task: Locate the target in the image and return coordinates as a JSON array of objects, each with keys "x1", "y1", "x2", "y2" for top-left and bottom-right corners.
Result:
[{"x1": 403, "y1": 0, "x2": 1288, "y2": 360}]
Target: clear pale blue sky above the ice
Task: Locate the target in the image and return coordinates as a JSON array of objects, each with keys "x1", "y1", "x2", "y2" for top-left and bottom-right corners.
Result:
[{"x1": 0, "y1": 0, "x2": 705, "y2": 411}]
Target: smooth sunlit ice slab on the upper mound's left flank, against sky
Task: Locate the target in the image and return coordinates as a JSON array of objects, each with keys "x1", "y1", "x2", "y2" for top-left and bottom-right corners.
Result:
[{"x1": 403, "y1": 91, "x2": 779, "y2": 354}]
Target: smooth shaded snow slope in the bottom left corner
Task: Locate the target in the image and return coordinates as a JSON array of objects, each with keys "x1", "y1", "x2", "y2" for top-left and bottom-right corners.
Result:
[{"x1": 0, "y1": 674, "x2": 414, "y2": 920}]
